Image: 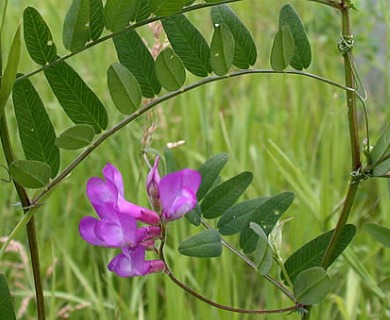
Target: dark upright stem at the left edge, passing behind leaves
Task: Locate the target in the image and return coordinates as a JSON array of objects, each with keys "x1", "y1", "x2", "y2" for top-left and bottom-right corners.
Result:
[{"x1": 0, "y1": 114, "x2": 45, "y2": 320}]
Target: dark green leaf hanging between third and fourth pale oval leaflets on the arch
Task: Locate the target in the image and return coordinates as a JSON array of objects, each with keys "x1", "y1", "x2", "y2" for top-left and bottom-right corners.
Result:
[{"x1": 113, "y1": 31, "x2": 161, "y2": 98}]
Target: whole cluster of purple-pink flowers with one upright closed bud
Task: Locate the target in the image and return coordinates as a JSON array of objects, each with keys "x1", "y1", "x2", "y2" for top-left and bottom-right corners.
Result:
[{"x1": 79, "y1": 158, "x2": 201, "y2": 277}]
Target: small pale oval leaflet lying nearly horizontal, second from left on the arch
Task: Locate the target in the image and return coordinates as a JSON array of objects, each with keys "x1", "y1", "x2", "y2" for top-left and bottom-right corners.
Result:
[{"x1": 55, "y1": 124, "x2": 95, "y2": 150}]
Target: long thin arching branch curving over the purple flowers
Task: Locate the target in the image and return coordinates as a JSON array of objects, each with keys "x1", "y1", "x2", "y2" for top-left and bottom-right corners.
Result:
[{"x1": 32, "y1": 69, "x2": 355, "y2": 206}]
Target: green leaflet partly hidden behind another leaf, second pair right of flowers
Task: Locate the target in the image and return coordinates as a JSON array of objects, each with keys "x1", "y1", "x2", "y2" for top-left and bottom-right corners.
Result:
[{"x1": 218, "y1": 197, "x2": 269, "y2": 236}]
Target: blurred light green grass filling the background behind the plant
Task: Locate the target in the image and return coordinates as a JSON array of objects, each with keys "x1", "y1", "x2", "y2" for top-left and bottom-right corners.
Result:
[{"x1": 0, "y1": 0, "x2": 390, "y2": 320}]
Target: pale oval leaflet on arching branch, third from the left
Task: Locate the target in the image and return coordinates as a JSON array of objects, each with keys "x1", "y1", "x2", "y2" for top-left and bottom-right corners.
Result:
[{"x1": 107, "y1": 63, "x2": 142, "y2": 114}]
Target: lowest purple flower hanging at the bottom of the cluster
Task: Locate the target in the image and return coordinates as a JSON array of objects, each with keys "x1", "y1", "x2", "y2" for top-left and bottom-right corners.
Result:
[{"x1": 108, "y1": 245, "x2": 165, "y2": 277}]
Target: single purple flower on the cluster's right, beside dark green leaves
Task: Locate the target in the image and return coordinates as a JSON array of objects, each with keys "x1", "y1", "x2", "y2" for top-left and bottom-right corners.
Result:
[{"x1": 158, "y1": 169, "x2": 202, "y2": 221}]
